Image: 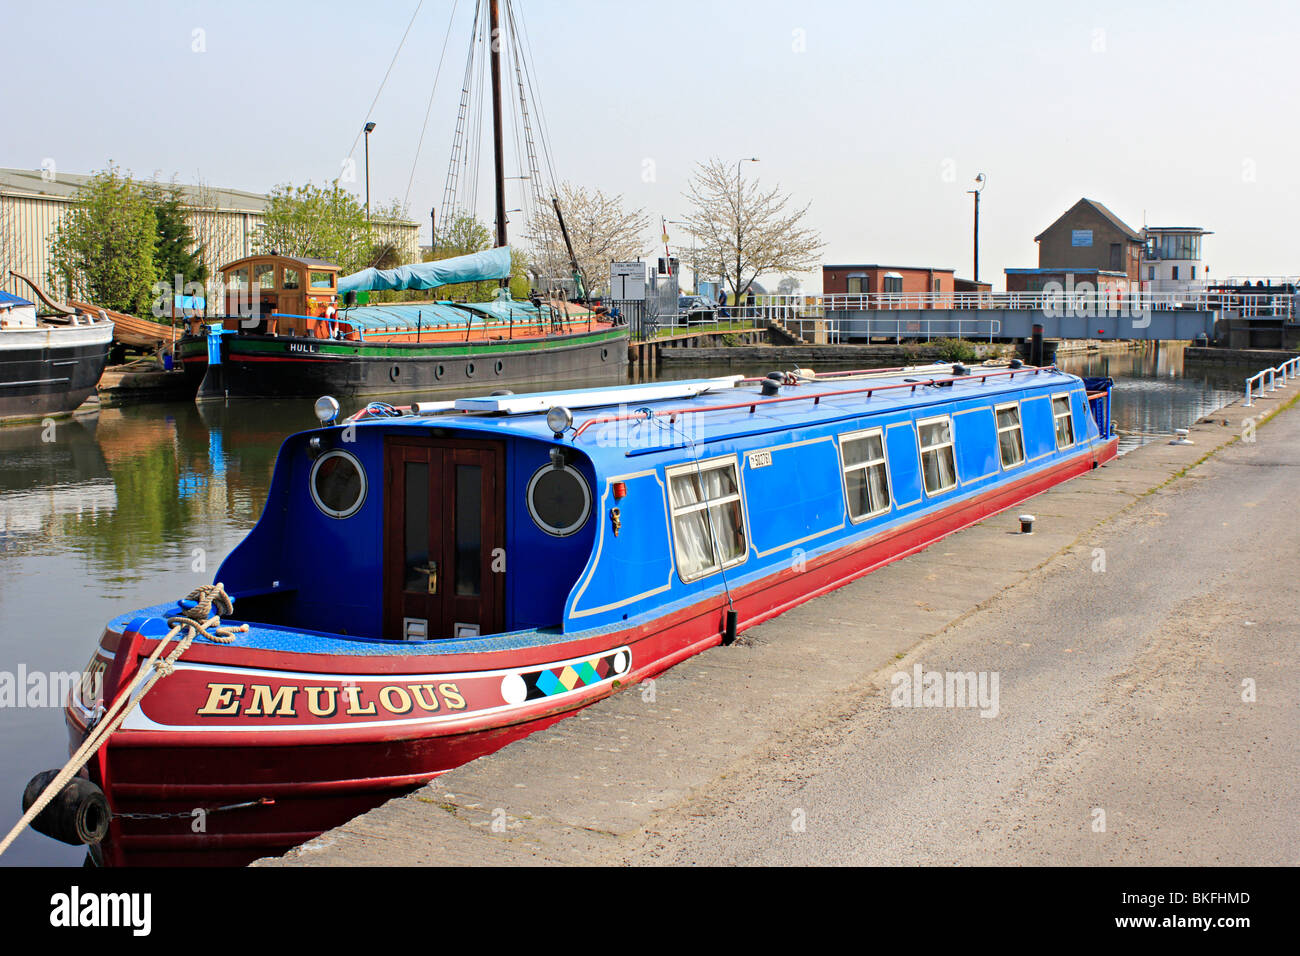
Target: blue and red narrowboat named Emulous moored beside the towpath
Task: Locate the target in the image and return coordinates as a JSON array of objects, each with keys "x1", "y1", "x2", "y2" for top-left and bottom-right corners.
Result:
[{"x1": 55, "y1": 362, "x2": 1117, "y2": 864}]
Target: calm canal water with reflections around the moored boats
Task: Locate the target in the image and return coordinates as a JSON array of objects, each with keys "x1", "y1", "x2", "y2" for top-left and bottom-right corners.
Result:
[{"x1": 0, "y1": 346, "x2": 1244, "y2": 865}]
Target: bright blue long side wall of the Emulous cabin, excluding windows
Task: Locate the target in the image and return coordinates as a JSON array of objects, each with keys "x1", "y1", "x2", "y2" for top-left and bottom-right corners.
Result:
[{"x1": 564, "y1": 375, "x2": 1102, "y2": 631}]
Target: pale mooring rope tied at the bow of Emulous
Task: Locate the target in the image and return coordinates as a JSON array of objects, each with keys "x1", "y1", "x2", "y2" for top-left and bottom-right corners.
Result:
[{"x1": 0, "y1": 584, "x2": 248, "y2": 856}]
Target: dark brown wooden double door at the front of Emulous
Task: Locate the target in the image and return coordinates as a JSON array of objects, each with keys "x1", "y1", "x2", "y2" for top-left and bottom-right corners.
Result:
[{"x1": 384, "y1": 438, "x2": 506, "y2": 640}]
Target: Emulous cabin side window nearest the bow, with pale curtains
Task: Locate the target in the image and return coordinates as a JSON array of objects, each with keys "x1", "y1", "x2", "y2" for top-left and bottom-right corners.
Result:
[{"x1": 668, "y1": 458, "x2": 749, "y2": 581}]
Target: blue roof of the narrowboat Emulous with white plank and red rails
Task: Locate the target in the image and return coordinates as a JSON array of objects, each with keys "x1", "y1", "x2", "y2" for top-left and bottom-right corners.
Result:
[{"x1": 354, "y1": 364, "x2": 1079, "y2": 457}]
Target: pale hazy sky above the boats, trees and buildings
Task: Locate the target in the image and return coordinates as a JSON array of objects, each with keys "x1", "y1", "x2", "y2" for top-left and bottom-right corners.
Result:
[{"x1": 0, "y1": 0, "x2": 1300, "y2": 287}]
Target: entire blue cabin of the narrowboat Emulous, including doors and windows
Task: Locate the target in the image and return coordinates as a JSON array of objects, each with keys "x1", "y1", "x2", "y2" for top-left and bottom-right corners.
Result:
[{"x1": 217, "y1": 372, "x2": 1106, "y2": 649}]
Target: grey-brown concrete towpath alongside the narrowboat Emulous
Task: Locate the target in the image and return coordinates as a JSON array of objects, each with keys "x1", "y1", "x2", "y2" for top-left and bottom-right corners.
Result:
[{"x1": 260, "y1": 388, "x2": 1300, "y2": 866}]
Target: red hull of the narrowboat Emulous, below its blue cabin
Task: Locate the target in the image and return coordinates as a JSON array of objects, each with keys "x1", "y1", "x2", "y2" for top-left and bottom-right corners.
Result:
[{"x1": 68, "y1": 440, "x2": 1117, "y2": 865}]
